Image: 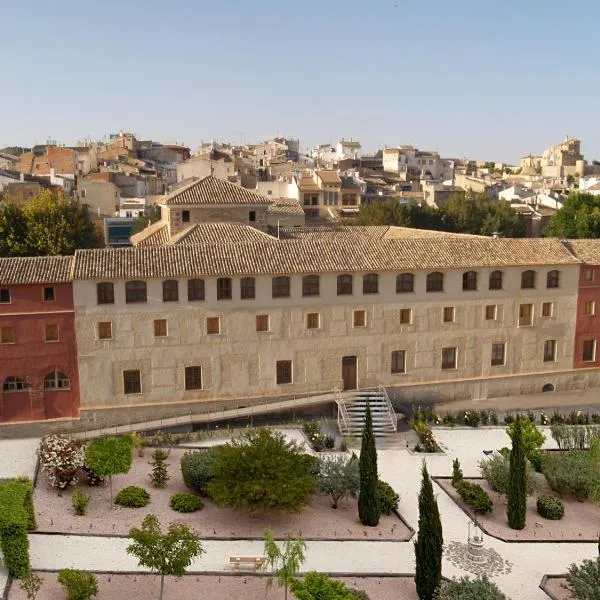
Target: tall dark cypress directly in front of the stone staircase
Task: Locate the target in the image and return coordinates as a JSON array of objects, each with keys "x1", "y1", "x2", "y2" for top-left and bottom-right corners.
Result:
[{"x1": 358, "y1": 403, "x2": 380, "y2": 527}]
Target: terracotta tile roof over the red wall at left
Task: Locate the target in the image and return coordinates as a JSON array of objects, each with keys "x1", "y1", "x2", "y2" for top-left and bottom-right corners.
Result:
[{"x1": 0, "y1": 256, "x2": 74, "y2": 285}]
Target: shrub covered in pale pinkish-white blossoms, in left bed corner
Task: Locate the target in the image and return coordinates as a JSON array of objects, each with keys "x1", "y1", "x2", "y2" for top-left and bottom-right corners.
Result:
[{"x1": 38, "y1": 435, "x2": 85, "y2": 491}]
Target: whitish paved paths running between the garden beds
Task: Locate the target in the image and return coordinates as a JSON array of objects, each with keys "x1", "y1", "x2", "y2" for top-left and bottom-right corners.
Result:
[{"x1": 0, "y1": 427, "x2": 597, "y2": 600}]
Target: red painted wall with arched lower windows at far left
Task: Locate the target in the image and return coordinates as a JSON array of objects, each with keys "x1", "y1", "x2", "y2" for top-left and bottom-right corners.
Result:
[{"x1": 0, "y1": 282, "x2": 79, "y2": 423}]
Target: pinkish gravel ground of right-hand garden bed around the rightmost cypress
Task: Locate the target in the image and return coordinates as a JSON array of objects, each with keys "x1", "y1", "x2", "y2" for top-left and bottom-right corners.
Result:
[{"x1": 436, "y1": 473, "x2": 600, "y2": 542}]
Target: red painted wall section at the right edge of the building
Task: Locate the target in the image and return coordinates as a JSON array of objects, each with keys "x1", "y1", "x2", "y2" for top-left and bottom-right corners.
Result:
[{"x1": 573, "y1": 265, "x2": 600, "y2": 369}]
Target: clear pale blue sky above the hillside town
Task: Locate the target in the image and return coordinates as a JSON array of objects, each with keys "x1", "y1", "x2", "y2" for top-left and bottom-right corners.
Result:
[{"x1": 0, "y1": 0, "x2": 600, "y2": 163}]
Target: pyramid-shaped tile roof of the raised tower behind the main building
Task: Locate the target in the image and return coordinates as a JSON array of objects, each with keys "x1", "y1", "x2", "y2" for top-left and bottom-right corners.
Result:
[{"x1": 164, "y1": 175, "x2": 272, "y2": 206}]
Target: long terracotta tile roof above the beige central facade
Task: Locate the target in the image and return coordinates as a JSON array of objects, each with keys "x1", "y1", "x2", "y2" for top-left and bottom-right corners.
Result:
[{"x1": 75, "y1": 237, "x2": 579, "y2": 279}]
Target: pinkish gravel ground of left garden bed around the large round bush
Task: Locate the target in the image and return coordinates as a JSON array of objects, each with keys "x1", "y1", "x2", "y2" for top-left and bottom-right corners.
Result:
[{"x1": 34, "y1": 448, "x2": 412, "y2": 541}]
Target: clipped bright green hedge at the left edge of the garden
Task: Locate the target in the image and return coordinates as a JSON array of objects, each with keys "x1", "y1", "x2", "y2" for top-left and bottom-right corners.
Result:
[{"x1": 0, "y1": 477, "x2": 36, "y2": 578}]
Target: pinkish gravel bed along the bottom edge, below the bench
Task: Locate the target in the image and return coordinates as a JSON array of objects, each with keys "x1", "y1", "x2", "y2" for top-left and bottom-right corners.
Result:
[{"x1": 8, "y1": 572, "x2": 418, "y2": 600}]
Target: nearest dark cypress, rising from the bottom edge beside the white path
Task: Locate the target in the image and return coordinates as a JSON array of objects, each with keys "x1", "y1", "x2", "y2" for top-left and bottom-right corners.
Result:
[{"x1": 415, "y1": 461, "x2": 444, "y2": 600}]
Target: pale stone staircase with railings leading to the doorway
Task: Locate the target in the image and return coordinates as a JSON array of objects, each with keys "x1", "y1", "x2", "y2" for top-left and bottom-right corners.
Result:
[{"x1": 336, "y1": 385, "x2": 398, "y2": 437}]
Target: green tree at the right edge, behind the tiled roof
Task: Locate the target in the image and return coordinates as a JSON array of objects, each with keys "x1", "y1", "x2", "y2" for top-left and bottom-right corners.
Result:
[{"x1": 544, "y1": 192, "x2": 600, "y2": 239}]
